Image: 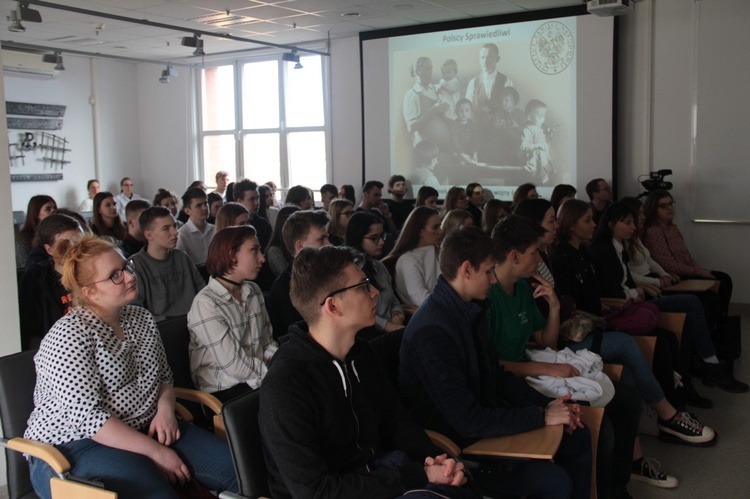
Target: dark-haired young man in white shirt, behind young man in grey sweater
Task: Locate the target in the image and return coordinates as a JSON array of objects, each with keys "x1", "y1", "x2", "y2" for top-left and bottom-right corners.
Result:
[{"x1": 177, "y1": 187, "x2": 216, "y2": 265}]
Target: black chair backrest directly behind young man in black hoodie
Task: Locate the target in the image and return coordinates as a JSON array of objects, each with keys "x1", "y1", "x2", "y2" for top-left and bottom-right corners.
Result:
[{"x1": 221, "y1": 390, "x2": 270, "y2": 499}]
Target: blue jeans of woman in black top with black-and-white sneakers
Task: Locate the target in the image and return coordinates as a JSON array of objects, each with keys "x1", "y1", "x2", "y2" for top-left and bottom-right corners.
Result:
[{"x1": 565, "y1": 331, "x2": 664, "y2": 405}]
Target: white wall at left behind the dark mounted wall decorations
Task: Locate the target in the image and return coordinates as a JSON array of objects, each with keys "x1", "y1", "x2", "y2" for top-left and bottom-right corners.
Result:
[{"x1": 5, "y1": 55, "x2": 144, "y2": 211}]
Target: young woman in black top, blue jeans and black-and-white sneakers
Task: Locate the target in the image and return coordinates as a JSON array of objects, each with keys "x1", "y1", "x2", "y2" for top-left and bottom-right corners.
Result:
[{"x1": 550, "y1": 199, "x2": 715, "y2": 432}]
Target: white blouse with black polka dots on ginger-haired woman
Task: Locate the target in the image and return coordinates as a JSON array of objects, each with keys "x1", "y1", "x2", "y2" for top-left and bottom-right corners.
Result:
[{"x1": 24, "y1": 306, "x2": 172, "y2": 445}]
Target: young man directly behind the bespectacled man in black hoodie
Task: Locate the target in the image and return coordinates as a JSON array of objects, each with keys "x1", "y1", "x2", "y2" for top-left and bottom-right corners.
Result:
[{"x1": 268, "y1": 210, "x2": 331, "y2": 341}]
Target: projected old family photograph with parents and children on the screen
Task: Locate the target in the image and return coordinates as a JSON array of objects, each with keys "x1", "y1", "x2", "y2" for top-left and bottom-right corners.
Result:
[{"x1": 391, "y1": 35, "x2": 575, "y2": 194}]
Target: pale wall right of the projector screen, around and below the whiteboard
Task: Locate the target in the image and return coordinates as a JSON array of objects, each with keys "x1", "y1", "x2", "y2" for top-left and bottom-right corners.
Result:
[{"x1": 618, "y1": 0, "x2": 750, "y2": 303}]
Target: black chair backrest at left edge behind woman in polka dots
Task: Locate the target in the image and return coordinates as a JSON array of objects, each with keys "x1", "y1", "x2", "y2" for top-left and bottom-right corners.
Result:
[{"x1": 0, "y1": 350, "x2": 36, "y2": 499}]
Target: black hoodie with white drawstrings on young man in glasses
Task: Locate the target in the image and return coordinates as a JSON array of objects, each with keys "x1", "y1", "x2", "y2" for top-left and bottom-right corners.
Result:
[{"x1": 259, "y1": 326, "x2": 442, "y2": 499}]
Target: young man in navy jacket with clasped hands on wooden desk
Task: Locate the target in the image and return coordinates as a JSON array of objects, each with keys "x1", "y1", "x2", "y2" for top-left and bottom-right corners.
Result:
[{"x1": 399, "y1": 226, "x2": 591, "y2": 497}]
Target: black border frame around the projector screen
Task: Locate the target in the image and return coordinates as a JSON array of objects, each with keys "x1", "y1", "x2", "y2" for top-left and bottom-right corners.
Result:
[{"x1": 359, "y1": 4, "x2": 619, "y2": 200}]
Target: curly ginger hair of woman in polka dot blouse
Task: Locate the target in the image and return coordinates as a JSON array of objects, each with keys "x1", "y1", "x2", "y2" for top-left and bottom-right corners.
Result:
[{"x1": 52, "y1": 236, "x2": 117, "y2": 305}]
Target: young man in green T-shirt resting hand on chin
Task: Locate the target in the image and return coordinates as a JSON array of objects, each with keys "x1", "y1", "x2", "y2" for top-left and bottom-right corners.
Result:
[{"x1": 487, "y1": 215, "x2": 656, "y2": 497}]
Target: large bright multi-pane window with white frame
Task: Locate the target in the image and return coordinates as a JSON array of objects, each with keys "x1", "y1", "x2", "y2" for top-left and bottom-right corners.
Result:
[{"x1": 199, "y1": 55, "x2": 330, "y2": 195}]
